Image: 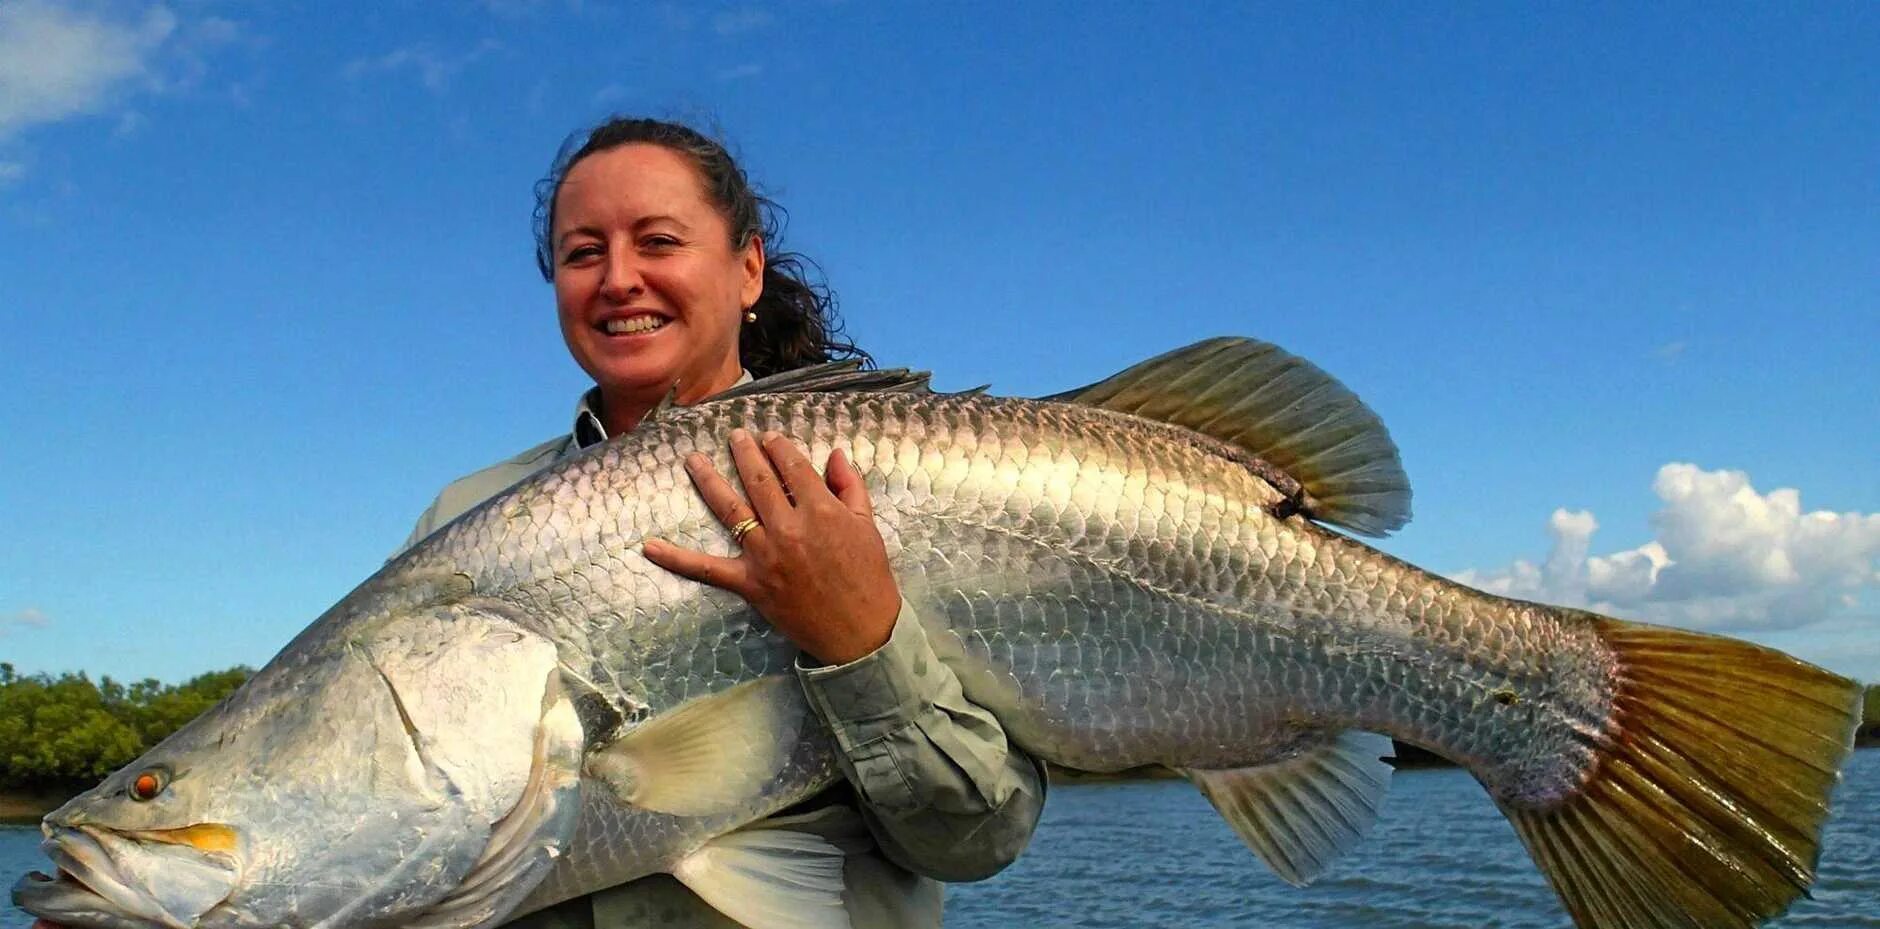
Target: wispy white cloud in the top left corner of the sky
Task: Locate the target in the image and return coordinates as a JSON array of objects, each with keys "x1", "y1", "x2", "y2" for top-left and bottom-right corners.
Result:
[{"x1": 0, "y1": 0, "x2": 177, "y2": 139}]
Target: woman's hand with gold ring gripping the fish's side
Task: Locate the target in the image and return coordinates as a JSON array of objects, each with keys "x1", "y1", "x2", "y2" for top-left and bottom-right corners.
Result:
[{"x1": 641, "y1": 429, "x2": 901, "y2": 664}]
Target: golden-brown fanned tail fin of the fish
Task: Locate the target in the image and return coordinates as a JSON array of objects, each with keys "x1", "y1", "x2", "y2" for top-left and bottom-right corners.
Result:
[{"x1": 1502, "y1": 617, "x2": 1861, "y2": 929}]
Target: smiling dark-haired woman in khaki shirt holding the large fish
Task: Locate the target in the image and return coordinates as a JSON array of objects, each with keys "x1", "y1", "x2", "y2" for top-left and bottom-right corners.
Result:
[{"x1": 406, "y1": 118, "x2": 1043, "y2": 929}]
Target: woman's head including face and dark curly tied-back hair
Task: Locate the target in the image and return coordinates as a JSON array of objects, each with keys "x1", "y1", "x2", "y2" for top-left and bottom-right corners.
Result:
[{"x1": 536, "y1": 118, "x2": 869, "y2": 431}]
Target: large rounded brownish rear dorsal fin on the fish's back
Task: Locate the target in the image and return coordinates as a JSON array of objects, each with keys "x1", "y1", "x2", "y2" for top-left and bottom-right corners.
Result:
[{"x1": 1045, "y1": 339, "x2": 1410, "y2": 536}]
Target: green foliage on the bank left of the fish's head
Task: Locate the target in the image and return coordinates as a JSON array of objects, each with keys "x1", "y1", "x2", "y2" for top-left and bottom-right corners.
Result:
[{"x1": 0, "y1": 662, "x2": 254, "y2": 790}]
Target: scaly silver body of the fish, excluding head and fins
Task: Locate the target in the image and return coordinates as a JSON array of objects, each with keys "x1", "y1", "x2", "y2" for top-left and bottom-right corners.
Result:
[{"x1": 404, "y1": 393, "x2": 1609, "y2": 906}]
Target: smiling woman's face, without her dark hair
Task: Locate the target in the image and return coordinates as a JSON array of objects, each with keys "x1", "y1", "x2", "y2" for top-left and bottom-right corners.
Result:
[{"x1": 551, "y1": 145, "x2": 763, "y2": 409}]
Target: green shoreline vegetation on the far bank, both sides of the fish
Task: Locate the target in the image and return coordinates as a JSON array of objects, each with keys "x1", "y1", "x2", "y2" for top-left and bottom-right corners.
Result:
[{"x1": 0, "y1": 662, "x2": 1880, "y2": 824}]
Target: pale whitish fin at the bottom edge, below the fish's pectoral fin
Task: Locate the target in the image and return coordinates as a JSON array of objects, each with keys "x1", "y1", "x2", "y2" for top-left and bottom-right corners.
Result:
[{"x1": 673, "y1": 829, "x2": 850, "y2": 929}]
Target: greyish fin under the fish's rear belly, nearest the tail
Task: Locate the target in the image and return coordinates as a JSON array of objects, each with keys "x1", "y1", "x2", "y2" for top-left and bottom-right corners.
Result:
[{"x1": 1179, "y1": 732, "x2": 1391, "y2": 888}]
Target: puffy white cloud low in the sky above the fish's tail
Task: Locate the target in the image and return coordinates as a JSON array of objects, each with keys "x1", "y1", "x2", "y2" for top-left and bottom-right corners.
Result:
[{"x1": 1455, "y1": 463, "x2": 1880, "y2": 634}]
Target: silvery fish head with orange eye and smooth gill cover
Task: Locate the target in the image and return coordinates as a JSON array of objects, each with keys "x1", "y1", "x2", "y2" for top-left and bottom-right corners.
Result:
[{"x1": 13, "y1": 607, "x2": 583, "y2": 929}]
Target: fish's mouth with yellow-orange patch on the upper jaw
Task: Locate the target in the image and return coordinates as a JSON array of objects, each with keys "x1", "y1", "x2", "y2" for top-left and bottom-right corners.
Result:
[{"x1": 13, "y1": 826, "x2": 237, "y2": 929}]
